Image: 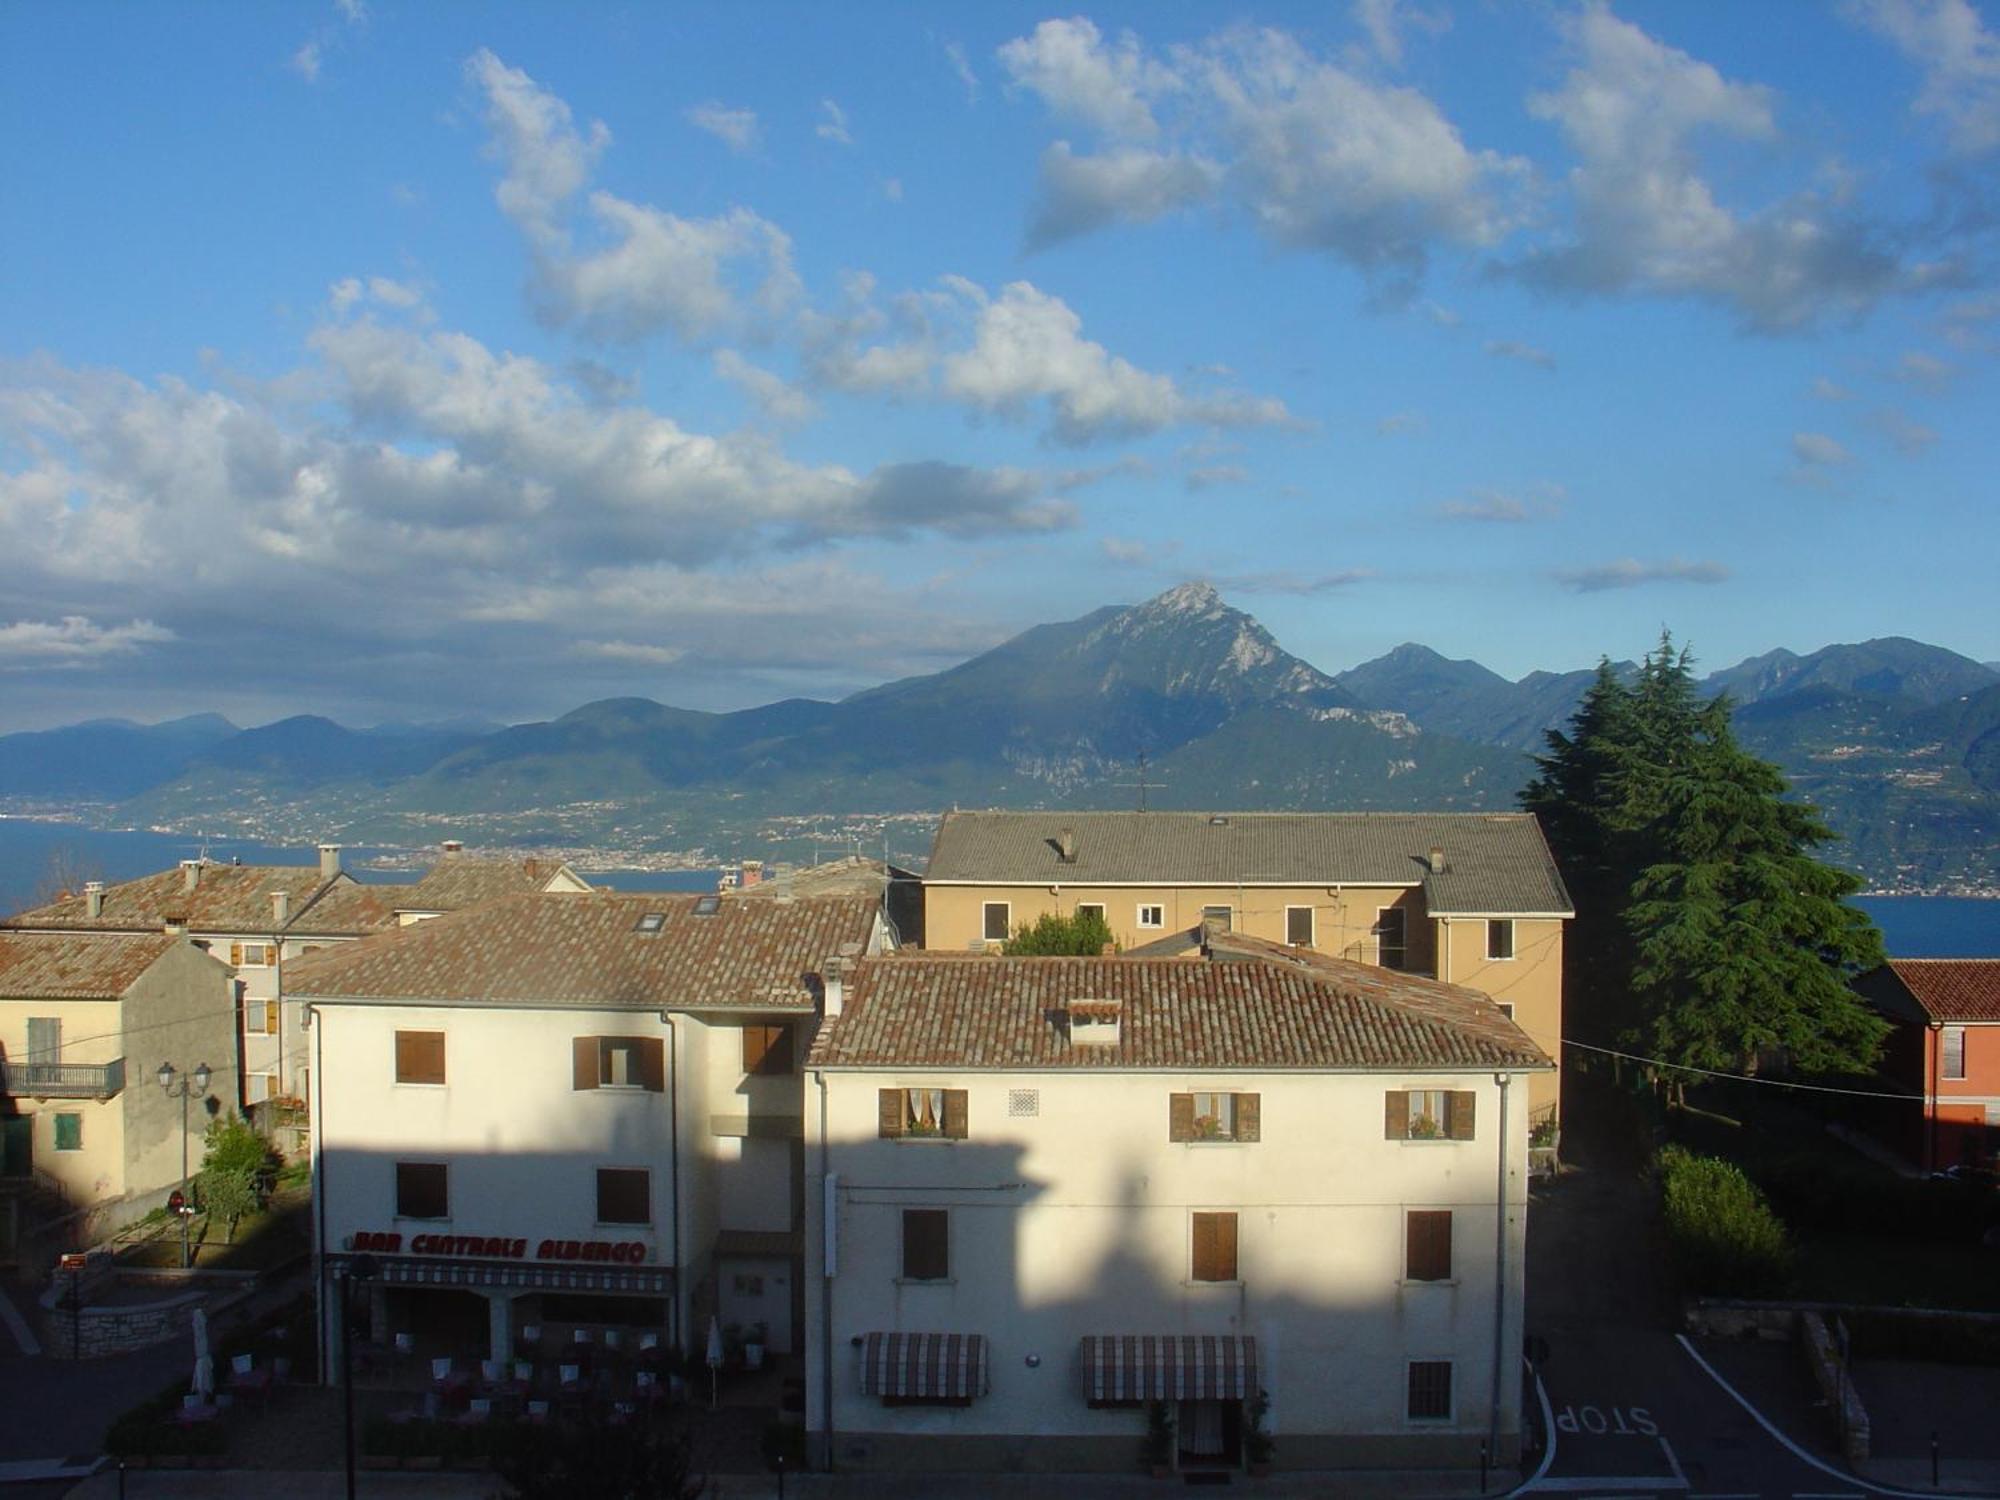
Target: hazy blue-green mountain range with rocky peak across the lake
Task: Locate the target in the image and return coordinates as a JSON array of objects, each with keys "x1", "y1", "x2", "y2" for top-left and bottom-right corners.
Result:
[{"x1": 0, "y1": 584, "x2": 2000, "y2": 890}]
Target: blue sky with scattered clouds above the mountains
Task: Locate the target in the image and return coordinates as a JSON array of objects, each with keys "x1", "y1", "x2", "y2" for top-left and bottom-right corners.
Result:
[{"x1": 0, "y1": 0, "x2": 2000, "y2": 730}]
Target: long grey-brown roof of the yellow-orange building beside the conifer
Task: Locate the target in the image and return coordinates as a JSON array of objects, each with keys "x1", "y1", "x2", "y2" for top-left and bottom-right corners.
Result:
[{"x1": 924, "y1": 812, "x2": 1572, "y2": 916}]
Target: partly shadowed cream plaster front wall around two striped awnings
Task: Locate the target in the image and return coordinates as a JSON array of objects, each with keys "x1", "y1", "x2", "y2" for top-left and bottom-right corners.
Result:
[{"x1": 806, "y1": 1072, "x2": 1526, "y2": 1436}]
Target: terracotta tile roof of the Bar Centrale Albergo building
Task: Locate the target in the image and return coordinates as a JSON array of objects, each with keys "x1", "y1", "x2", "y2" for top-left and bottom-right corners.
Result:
[{"x1": 284, "y1": 892, "x2": 876, "y2": 1012}]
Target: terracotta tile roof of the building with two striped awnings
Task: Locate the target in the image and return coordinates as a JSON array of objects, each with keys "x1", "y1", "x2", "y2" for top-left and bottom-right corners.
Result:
[{"x1": 808, "y1": 954, "x2": 1552, "y2": 1072}]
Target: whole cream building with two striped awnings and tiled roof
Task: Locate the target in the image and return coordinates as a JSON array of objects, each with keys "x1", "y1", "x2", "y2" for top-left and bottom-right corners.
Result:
[{"x1": 806, "y1": 954, "x2": 1552, "y2": 1470}]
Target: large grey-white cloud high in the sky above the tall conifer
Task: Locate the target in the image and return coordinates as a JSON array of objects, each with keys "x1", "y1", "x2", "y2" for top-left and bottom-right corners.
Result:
[{"x1": 1518, "y1": 0, "x2": 1898, "y2": 332}]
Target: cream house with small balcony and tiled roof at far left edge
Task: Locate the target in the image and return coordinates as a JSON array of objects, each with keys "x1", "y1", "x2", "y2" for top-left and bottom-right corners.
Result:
[{"x1": 0, "y1": 932, "x2": 236, "y2": 1228}]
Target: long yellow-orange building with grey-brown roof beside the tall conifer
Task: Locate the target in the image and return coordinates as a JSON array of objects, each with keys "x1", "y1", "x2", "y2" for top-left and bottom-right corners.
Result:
[{"x1": 924, "y1": 812, "x2": 1576, "y2": 1124}]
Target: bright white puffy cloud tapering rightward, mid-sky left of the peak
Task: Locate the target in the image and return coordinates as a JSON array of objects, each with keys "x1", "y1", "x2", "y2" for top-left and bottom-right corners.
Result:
[{"x1": 942, "y1": 282, "x2": 1292, "y2": 442}]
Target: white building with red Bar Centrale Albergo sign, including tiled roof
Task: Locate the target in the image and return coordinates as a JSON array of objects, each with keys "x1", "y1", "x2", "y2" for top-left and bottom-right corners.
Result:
[{"x1": 286, "y1": 892, "x2": 882, "y2": 1384}]
